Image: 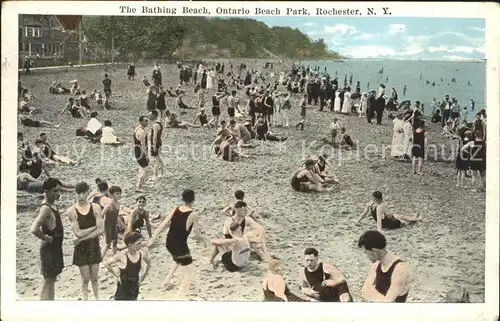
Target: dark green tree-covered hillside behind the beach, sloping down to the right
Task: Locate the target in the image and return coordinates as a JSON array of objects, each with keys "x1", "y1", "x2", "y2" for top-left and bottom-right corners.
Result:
[{"x1": 82, "y1": 16, "x2": 343, "y2": 59}]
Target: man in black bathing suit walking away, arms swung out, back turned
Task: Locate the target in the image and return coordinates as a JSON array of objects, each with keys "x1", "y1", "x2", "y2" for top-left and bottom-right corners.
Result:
[{"x1": 147, "y1": 189, "x2": 208, "y2": 297}]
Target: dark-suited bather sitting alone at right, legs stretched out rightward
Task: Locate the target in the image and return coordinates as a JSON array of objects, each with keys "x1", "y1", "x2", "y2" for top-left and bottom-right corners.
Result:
[{"x1": 357, "y1": 191, "x2": 421, "y2": 232}]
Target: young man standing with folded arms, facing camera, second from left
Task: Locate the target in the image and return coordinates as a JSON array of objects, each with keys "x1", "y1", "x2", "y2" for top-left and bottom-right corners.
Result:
[{"x1": 66, "y1": 182, "x2": 104, "y2": 301}]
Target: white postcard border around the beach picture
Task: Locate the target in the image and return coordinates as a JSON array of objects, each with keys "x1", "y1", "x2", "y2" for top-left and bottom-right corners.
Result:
[{"x1": 0, "y1": 1, "x2": 500, "y2": 321}]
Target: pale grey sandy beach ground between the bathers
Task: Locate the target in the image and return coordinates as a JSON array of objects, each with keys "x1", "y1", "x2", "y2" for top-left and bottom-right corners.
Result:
[{"x1": 16, "y1": 62, "x2": 485, "y2": 302}]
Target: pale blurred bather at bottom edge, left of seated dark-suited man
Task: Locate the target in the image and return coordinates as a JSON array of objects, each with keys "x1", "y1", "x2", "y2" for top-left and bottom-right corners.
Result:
[{"x1": 262, "y1": 259, "x2": 309, "y2": 302}]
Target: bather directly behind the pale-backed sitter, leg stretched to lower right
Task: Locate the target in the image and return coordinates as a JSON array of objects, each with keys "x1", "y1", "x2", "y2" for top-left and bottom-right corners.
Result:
[{"x1": 222, "y1": 201, "x2": 272, "y2": 262}]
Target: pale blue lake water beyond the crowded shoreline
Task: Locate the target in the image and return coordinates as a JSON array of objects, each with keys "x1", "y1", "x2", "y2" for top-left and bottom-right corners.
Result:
[{"x1": 301, "y1": 60, "x2": 486, "y2": 119}]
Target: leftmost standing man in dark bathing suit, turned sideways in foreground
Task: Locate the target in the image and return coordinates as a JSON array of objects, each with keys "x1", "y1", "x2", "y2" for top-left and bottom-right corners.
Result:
[{"x1": 31, "y1": 177, "x2": 64, "y2": 300}]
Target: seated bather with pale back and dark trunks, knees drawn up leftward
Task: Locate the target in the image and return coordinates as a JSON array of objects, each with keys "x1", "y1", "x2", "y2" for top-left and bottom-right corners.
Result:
[{"x1": 210, "y1": 222, "x2": 251, "y2": 272}]
